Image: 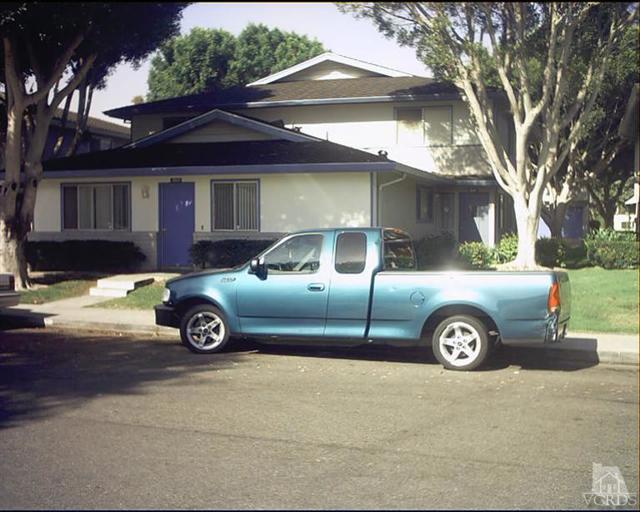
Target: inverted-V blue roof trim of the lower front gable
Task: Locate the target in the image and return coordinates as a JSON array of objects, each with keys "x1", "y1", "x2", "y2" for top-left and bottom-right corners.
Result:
[{"x1": 125, "y1": 108, "x2": 317, "y2": 148}]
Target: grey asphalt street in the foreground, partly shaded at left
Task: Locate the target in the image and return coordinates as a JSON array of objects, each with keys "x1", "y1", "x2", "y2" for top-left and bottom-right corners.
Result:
[{"x1": 0, "y1": 329, "x2": 638, "y2": 509}]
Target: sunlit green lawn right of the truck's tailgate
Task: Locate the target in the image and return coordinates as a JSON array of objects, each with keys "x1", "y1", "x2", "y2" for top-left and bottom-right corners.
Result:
[{"x1": 568, "y1": 267, "x2": 638, "y2": 334}]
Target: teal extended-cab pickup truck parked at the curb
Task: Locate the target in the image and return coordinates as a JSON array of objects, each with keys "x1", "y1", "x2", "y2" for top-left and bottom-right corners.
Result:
[{"x1": 155, "y1": 228, "x2": 571, "y2": 370}]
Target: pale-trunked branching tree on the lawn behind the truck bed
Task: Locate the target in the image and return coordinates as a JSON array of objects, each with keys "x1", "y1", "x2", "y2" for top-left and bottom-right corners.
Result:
[{"x1": 339, "y1": 2, "x2": 637, "y2": 268}]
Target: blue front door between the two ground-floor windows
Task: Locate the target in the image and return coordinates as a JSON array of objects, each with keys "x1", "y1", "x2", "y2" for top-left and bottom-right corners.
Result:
[{"x1": 159, "y1": 183, "x2": 195, "y2": 267}]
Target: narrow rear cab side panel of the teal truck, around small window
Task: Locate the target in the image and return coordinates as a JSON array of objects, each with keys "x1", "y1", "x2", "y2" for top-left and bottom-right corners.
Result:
[{"x1": 324, "y1": 231, "x2": 379, "y2": 338}]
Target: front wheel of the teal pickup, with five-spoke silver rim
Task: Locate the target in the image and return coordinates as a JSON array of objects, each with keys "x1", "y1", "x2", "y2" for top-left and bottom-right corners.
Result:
[{"x1": 180, "y1": 304, "x2": 230, "y2": 354}]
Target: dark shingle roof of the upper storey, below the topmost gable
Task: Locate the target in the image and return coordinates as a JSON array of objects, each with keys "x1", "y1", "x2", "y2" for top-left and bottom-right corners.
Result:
[{"x1": 105, "y1": 77, "x2": 500, "y2": 119}]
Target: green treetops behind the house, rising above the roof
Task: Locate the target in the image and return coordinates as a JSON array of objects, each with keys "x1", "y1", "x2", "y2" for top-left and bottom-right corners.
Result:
[{"x1": 147, "y1": 23, "x2": 325, "y2": 101}]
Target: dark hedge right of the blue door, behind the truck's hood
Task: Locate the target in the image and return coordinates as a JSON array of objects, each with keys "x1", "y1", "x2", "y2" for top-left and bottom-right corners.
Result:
[{"x1": 189, "y1": 240, "x2": 275, "y2": 268}]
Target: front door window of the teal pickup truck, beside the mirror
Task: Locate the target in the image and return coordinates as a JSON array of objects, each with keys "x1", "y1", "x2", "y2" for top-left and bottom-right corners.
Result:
[{"x1": 264, "y1": 235, "x2": 324, "y2": 274}]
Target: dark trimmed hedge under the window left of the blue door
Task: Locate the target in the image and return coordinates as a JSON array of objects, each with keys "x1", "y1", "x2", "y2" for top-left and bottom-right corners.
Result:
[{"x1": 25, "y1": 240, "x2": 146, "y2": 271}]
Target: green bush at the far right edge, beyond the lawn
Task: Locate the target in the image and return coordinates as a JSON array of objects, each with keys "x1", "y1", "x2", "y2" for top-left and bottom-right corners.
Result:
[{"x1": 585, "y1": 229, "x2": 639, "y2": 269}]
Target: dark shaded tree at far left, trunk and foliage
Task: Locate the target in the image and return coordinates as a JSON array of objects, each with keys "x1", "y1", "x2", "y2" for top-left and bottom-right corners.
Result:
[{"x1": 0, "y1": 2, "x2": 186, "y2": 286}]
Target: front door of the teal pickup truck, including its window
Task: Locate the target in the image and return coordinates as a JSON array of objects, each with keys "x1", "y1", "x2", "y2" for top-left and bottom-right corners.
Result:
[{"x1": 237, "y1": 232, "x2": 333, "y2": 337}]
